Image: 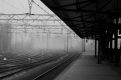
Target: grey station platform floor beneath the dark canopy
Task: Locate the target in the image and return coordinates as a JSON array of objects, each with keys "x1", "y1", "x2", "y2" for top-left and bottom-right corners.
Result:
[{"x1": 54, "y1": 52, "x2": 121, "y2": 80}]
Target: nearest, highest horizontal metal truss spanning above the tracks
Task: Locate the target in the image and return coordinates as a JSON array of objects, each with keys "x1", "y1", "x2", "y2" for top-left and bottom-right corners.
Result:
[{"x1": 0, "y1": 14, "x2": 62, "y2": 22}]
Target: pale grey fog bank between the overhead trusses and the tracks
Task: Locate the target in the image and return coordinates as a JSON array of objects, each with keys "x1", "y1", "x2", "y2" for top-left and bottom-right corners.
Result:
[{"x1": 0, "y1": 22, "x2": 82, "y2": 56}]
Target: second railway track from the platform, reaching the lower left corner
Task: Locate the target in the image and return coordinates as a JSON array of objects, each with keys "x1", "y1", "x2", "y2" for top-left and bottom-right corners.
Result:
[{"x1": 0, "y1": 55, "x2": 63, "y2": 80}]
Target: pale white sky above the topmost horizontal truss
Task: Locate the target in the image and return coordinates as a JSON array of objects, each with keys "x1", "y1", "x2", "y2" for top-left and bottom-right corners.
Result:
[{"x1": 0, "y1": 0, "x2": 53, "y2": 14}]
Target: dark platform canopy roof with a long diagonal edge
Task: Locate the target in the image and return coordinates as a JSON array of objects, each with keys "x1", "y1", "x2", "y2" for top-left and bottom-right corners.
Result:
[{"x1": 41, "y1": 0, "x2": 121, "y2": 38}]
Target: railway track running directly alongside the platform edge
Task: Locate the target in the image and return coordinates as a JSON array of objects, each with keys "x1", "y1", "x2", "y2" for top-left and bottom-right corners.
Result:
[{"x1": 32, "y1": 54, "x2": 80, "y2": 80}]
